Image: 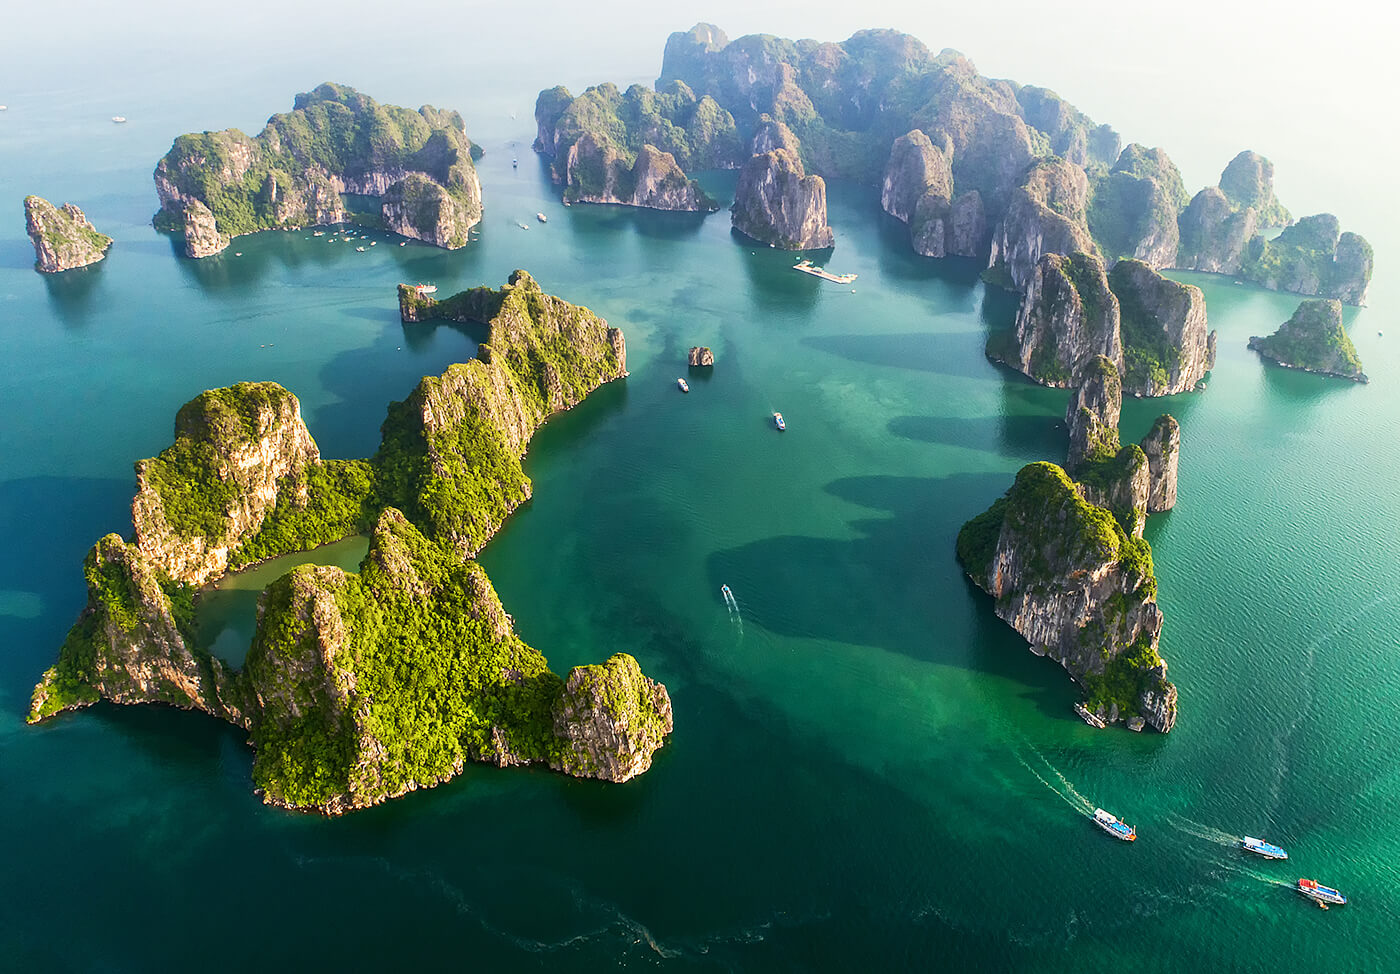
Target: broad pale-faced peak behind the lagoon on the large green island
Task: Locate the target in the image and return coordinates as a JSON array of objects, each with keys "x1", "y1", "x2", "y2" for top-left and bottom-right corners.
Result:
[{"x1": 132, "y1": 382, "x2": 321, "y2": 585}]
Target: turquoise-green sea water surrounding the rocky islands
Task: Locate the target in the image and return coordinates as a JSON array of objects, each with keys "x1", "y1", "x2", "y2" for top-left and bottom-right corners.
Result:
[{"x1": 0, "y1": 19, "x2": 1400, "y2": 971}]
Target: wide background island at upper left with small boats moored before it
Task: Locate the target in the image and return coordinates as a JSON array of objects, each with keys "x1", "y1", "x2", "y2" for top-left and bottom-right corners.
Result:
[{"x1": 155, "y1": 83, "x2": 482, "y2": 257}]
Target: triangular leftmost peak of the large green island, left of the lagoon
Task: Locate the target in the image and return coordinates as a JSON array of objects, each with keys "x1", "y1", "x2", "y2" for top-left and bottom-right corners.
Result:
[{"x1": 28, "y1": 535, "x2": 248, "y2": 726}]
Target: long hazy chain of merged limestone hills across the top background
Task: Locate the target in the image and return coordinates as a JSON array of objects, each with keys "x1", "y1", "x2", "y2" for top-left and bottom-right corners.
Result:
[{"x1": 535, "y1": 24, "x2": 1373, "y2": 304}]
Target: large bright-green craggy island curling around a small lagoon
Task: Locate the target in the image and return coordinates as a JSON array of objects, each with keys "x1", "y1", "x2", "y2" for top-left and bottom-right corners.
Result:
[{"x1": 29, "y1": 270, "x2": 672, "y2": 814}]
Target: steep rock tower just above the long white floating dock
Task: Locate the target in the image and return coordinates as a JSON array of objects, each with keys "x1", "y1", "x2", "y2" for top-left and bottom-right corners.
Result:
[{"x1": 732, "y1": 148, "x2": 834, "y2": 250}]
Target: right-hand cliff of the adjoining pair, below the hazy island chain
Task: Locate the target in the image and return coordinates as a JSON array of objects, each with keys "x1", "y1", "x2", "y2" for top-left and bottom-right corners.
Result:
[{"x1": 1109, "y1": 259, "x2": 1215, "y2": 396}]
